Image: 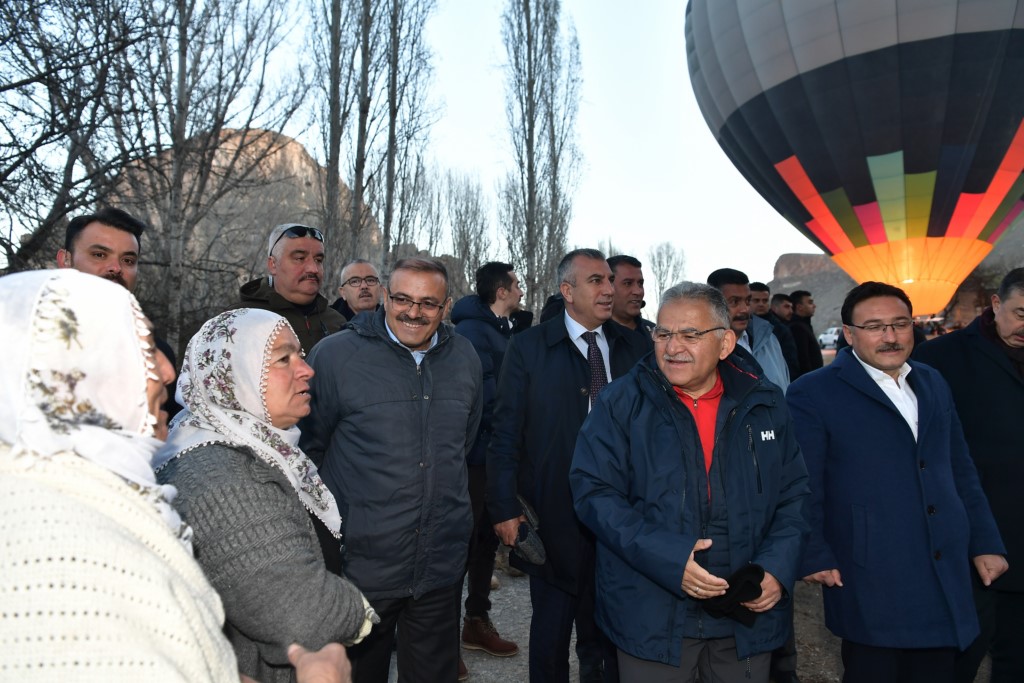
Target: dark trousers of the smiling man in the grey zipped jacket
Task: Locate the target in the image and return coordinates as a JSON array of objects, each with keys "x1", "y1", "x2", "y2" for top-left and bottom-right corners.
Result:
[{"x1": 348, "y1": 584, "x2": 462, "y2": 683}]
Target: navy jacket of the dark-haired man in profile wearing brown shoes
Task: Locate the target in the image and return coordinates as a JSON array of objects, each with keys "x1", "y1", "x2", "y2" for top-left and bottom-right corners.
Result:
[{"x1": 452, "y1": 294, "x2": 512, "y2": 465}]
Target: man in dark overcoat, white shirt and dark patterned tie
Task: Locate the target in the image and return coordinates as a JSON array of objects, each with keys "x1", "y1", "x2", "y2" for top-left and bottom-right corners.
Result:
[{"x1": 487, "y1": 249, "x2": 644, "y2": 683}]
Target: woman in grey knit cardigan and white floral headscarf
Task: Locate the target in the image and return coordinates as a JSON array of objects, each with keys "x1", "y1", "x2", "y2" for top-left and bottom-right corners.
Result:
[{"x1": 156, "y1": 308, "x2": 376, "y2": 683}]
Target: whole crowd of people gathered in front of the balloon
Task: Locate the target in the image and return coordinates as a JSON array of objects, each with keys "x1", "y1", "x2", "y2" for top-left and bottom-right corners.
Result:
[{"x1": 0, "y1": 209, "x2": 1024, "y2": 683}]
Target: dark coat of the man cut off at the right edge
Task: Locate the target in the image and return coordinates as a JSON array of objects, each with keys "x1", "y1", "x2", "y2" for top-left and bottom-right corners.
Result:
[{"x1": 913, "y1": 319, "x2": 1024, "y2": 593}]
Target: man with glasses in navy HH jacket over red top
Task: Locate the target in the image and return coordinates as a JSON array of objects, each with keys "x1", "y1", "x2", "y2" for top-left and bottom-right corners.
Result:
[{"x1": 569, "y1": 283, "x2": 808, "y2": 683}]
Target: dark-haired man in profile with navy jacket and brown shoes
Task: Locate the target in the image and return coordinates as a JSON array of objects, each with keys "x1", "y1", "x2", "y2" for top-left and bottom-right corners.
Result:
[{"x1": 452, "y1": 261, "x2": 522, "y2": 673}]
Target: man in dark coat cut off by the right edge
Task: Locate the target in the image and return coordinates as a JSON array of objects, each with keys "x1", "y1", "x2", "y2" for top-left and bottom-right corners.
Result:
[{"x1": 913, "y1": 268, "x2": 1024, "y2": 683}]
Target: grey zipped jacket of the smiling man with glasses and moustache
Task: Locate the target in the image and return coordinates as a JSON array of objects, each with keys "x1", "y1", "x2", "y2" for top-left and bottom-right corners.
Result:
[{"x1": 299, "y1": 308, "x2": 482, "y2": 600}]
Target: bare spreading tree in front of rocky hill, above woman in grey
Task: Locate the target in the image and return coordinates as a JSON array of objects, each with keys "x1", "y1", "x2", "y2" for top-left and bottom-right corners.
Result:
[{"x1": 105, "y1": 0, "x2": 304, "y2": 348}]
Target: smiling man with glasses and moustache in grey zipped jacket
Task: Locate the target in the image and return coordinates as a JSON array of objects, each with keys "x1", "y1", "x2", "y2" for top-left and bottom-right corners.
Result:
[{"x1": 299, "y1": 258, "x2": 483, "y2": 683}]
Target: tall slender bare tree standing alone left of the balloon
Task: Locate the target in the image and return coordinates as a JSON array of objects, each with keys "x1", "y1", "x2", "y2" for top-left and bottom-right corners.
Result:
[{"x1": 499, "y1": 0, "x2": 581, "y2": 309}]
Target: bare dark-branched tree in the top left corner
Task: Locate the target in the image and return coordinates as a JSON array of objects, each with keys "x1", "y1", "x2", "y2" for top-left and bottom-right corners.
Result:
[{"x1": 0, "y1": 0, "x2": 152, "y2": 270}]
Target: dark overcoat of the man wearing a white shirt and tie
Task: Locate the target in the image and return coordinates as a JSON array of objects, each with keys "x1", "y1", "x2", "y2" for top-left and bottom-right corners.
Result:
[{"x1": 487, "y1": 314, "x2": 644, "y2": 594}]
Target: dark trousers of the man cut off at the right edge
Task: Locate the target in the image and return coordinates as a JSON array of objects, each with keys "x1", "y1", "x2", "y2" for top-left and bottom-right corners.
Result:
[{"x1": 956, "y1": 574, "x2": 1024, "y2": 683}]
